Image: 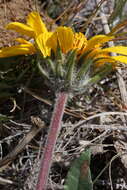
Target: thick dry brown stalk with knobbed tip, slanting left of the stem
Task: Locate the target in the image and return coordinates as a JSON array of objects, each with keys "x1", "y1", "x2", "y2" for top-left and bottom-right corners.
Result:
[{"x1": 0, "y1": 117, "x2": 45, "y2": 167}]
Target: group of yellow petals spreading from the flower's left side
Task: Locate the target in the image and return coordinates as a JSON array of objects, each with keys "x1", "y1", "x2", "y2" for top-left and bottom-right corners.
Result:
[{"x1": 0, "y1": 12, "x2": 51, "y2": 57}]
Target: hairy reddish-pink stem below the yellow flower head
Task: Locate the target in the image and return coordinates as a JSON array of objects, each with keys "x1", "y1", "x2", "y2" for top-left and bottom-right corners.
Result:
[{"x1": 36, "y1": 92, "x2": 68, "y2": 190}]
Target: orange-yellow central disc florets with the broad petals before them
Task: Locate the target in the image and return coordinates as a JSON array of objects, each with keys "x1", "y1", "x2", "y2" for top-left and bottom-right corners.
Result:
[{"x1": 47, "y1": 26, "x2": 87, "y2": 54}]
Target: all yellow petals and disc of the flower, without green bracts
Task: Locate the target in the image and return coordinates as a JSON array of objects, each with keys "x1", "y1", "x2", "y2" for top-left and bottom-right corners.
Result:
[{"x1": 0, "y1": 12, "x2": 127, "y2": 65}]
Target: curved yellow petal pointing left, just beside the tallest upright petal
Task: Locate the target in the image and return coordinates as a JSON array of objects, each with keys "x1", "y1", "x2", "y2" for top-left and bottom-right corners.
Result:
[{"x1": 6, "y1": 22, "x2": 35, "y2": 38}]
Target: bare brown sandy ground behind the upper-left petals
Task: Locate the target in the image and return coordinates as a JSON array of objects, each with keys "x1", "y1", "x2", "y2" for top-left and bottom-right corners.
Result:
[{"x1": 0, "y1": 0, "x2": 35, "y2": 47}]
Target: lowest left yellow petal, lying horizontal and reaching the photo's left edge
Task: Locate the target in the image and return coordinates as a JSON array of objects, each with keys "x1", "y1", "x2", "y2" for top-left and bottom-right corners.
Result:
[{"x1": 0, "y1": 44, "x2": 36, "y2": 58}]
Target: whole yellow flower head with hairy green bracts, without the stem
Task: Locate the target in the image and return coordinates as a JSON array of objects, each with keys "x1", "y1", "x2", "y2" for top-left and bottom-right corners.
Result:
[{"x1": 0, "y1": 12, "x2": 127, "y2": 93}]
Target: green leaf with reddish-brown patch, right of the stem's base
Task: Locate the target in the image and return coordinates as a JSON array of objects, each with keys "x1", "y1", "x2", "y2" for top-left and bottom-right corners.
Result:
[{"x1": 64, "y1": 149, "x2": 93, "y2": 190}]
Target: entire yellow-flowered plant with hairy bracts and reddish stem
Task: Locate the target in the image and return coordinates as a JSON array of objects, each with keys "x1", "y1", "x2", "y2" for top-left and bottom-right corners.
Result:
[{"x1": 0, "y1": 12, "x2": 127, "y2": 190}]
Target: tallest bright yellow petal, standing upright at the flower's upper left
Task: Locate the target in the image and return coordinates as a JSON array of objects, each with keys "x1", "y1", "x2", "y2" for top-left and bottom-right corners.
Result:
[{"x1": 27, "y1": 12, "x2": 48, "y2": 36}]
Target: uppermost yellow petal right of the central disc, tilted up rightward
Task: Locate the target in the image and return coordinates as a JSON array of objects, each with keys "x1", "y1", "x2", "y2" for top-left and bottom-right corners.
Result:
[{"x1": 85, "y1": 35, "x2": 114, "y2": 51}]
